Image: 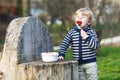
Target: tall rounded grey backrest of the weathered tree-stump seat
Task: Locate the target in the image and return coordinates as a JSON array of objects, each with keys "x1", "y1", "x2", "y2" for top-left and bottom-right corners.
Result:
[{"x1": 3, "y1": 17, "x2": 53, "y2": 63}]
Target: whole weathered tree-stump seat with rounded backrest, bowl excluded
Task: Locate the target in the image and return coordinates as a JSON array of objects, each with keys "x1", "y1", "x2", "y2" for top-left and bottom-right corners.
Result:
[{"x1": 0, "y1": 17, "x2": 78, "y2": 80}]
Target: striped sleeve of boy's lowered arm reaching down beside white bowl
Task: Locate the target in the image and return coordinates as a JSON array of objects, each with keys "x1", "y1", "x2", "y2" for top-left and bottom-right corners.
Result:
[{"x1": 59, "y1": 31, "x2": 72, "y2": 57}]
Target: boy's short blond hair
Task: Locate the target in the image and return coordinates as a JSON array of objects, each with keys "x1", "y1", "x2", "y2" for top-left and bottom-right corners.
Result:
[{"x1": 74, "y1": 7, "x2": 95, "y2": 25}]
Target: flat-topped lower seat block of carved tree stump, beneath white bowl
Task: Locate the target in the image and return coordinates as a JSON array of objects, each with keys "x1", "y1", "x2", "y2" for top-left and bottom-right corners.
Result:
[{"x1": 17, "y1": 61, "x2": 78, "y2": 80}]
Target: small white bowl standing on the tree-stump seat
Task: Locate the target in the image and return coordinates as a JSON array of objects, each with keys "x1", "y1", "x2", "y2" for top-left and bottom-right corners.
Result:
[{"x1": 41, "y1": 52, "x2": 58, "y2": 62}]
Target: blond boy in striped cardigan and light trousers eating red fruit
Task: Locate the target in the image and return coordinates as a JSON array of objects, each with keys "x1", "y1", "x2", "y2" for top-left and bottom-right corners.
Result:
[{"x1": 58, "y1": 8, "x2": 98, "y2": 80}]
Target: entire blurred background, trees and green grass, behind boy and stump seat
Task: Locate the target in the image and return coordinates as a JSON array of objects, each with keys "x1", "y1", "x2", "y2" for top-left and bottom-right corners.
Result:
[{"x1": 0, "y1": 0, "x2": 120, "y2": 80}]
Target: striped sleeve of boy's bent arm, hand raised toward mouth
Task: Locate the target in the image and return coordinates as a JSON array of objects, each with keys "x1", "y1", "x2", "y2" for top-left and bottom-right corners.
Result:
[{"x1": 85, "y1": 30, "x2": 99, "y2": 49}]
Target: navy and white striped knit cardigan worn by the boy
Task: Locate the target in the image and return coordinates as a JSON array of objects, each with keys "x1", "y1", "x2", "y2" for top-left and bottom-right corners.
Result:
[{"x1": 59, "y1": 27, "x2": 98, "y2": 64}]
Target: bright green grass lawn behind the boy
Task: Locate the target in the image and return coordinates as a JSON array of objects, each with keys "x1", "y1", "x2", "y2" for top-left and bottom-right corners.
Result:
[{"x1": 65, "y1": 47, "x2": 120, "y2": 80}]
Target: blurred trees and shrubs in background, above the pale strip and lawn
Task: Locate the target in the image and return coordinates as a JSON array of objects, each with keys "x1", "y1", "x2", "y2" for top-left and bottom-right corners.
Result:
[{"x1": 0, "y1": 0, "x2": 120, "y2": 46}]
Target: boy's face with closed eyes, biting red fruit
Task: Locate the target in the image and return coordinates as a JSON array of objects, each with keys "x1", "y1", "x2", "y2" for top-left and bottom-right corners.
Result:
[{"x1": 75, "y1": 12, "x2": 89, "y2": 28}]
